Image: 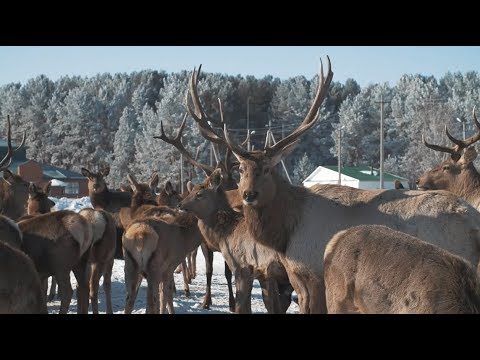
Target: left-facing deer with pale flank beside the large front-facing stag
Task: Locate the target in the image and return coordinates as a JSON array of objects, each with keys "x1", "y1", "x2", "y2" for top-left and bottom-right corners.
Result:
[{"x1": 179, "y1": 169, "x2": 290, "y2": 314}]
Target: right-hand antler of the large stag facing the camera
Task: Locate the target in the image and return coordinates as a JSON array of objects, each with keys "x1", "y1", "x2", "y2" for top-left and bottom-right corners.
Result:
[{"x1": 265, "y1": 56, "x2": 333, "y2": 155}]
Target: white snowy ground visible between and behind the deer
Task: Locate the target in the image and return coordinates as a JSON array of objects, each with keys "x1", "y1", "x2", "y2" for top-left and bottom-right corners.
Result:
[{"x1": 48, "y1": 197, "x2": 299, "y2": 314}]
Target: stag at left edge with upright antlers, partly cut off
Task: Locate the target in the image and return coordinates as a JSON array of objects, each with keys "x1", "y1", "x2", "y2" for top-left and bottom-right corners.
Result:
[{"x1": 0, "y1": 116, "x2": 29, "y2": 221}]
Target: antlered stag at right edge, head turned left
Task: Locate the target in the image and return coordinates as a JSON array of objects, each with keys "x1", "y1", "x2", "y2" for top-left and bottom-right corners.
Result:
[{"x1": 417, "y1": 108, "x2": 480, "y2": 210}]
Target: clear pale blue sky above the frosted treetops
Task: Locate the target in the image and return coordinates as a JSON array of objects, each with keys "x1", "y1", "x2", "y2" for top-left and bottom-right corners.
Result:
[{"x1": 0, "y1": 46, "x2": 480, "y2": 86}]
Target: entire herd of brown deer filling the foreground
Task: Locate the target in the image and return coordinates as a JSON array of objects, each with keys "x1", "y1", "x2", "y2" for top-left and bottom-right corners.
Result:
[{"x1": 0, "y1": 59, "x2": 480, "y2": 313}]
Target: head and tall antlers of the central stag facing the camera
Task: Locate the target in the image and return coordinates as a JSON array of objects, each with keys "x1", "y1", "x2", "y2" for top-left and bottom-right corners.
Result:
[{"x1": 186, "y1": 57, "x2": 333, "y2": 206}]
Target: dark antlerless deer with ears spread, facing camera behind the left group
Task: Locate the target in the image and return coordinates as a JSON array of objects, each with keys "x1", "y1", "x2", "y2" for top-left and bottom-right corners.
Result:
[{"x1": 81, "y1": 166, "x2": 132, "y2": 259}]
